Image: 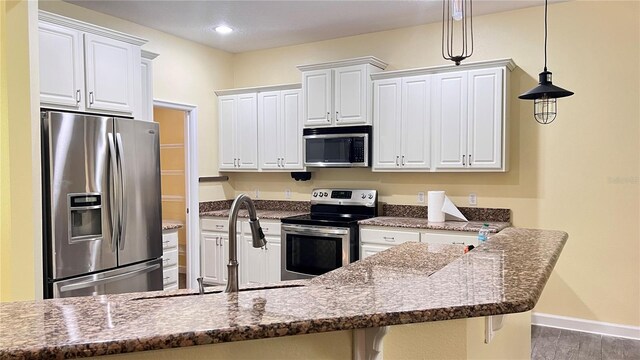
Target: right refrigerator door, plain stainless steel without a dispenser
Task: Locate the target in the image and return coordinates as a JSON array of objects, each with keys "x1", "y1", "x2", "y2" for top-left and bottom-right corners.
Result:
[{"x1": 115, "y1": 119, "x2": 162, "y2": 266}]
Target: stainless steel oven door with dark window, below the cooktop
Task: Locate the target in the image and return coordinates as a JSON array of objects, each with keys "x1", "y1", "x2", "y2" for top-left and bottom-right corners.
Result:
[{"x1": 281, "y1": 224, "x2": 351, "y2": 280}]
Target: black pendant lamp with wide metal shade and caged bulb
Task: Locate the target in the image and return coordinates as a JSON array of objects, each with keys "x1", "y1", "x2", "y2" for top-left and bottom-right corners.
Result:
[{"x1": 518, "y1": 0, "x2": 573, "y2": 124}]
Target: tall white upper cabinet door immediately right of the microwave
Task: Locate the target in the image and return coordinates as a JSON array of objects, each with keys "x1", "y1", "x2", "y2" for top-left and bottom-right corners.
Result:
[{"x1": 373, "y1": 79, "x2": 402, "y2": 170}]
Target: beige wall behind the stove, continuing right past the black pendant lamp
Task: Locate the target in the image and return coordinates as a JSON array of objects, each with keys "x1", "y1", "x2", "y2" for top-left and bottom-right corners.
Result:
[{"x1": 231, "y1": 1, "x2": 640, "y2": 326}]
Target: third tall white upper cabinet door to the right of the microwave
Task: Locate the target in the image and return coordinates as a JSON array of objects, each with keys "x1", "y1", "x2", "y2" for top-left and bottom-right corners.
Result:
[{"x1": 432, "y1": 72, "x2": 468, "y2": 169}]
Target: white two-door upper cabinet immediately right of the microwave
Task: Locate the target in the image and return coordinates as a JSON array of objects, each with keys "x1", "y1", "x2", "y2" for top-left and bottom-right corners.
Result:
[{"x1": 373, "y1": 75, "x2": 431, "y2": 171}]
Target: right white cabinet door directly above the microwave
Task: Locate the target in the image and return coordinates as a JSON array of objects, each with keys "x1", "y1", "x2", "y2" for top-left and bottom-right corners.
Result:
[{"x1": 334, "y1": 65, "x2": 364, "y2": 125}]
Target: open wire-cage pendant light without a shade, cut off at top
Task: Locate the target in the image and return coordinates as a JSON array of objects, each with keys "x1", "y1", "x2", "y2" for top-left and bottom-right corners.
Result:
[{"x1": 442, "y1": 0, "x2": 473, "y2": 65}]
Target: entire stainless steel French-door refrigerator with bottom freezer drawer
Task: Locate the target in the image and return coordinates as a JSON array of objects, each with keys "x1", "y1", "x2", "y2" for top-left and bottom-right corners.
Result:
[{"x1": 41, "y1": 111, "x2": 163, "y2": 298}]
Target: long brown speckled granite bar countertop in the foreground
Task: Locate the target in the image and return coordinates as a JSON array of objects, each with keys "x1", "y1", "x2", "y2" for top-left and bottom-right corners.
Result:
[{"x1": 0, "y1": 228, "x2": 567, "y2": 359}]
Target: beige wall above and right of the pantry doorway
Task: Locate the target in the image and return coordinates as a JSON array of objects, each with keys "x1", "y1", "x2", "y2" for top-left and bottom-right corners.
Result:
[{"x1": 39, "y1": 0, "x2": 238, "y2": 201}]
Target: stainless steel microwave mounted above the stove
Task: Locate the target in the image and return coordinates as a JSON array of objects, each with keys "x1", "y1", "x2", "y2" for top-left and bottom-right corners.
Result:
[{"x1": 303, "y1": 126, "x2": 371, "y2": 167}]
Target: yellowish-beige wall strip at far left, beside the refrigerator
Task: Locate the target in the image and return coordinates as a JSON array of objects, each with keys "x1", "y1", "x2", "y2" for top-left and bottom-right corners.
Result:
[{"x1": 0, "y1": 1, "x2": 42, "y2": 301}]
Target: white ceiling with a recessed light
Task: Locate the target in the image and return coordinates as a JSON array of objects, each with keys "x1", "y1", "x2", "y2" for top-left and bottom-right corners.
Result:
[{"x1": 66, "y1": 0, "x2": 558, "y2": 53}]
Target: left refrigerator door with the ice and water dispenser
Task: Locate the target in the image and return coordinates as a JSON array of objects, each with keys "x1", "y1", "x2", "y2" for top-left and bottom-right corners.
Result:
[{"x1": 42, "y1": 112, "x2": 117, "y2": 279}]
